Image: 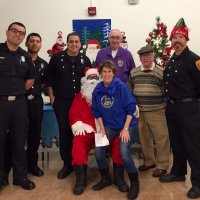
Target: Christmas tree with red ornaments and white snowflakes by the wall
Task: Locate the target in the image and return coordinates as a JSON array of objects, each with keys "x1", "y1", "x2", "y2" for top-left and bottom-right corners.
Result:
[{"x1": 146, "y1": 17, "x2": 172, "y2": 67}]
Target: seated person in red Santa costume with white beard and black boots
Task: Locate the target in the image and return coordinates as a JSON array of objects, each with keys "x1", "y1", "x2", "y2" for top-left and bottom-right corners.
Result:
[{"x1": 69, "y1": 68, "x2": 128, "y2": 195}]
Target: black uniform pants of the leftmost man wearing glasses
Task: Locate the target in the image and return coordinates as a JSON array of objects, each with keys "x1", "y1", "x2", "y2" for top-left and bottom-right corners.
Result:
[{"x1": 0, "y1": 97, "x2": 28, "y2": 180}]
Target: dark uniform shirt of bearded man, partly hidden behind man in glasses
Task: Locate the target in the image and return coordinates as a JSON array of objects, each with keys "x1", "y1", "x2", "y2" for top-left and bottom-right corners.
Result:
[{"x1": 27, "y1": 56, "x2": 48, "y2": 96}]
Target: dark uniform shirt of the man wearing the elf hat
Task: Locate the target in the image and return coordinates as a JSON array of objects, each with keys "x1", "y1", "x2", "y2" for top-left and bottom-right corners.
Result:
[{"x1": 163, "y1": 47, "x2": 200, "y2": 100}]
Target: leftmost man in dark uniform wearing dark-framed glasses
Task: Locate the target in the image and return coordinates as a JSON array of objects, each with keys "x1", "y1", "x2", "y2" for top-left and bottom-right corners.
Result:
[{"x1": 0, "y1": 22, "x2": 35, "y2": 190}]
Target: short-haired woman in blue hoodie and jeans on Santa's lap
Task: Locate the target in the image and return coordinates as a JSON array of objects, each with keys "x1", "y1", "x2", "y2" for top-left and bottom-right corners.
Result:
[{"x1": 92, "y1": 61, "x2": 139, "y2": 199}]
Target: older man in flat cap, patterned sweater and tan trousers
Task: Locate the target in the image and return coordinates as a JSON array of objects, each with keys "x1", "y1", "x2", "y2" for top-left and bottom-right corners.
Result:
[{"x1": 129, "y1": 46, "x2": 170, "y2": 177}]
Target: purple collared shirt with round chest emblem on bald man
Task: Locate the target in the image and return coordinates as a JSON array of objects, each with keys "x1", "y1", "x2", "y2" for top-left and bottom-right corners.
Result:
[{"x1": 95, "y1": 46, "x2": 135, "y2": 83}]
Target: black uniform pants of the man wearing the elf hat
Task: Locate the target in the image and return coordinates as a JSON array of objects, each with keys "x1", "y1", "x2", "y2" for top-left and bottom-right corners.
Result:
[{"x1": 166, "y1": 100, "x2": 200, "y2": 186}]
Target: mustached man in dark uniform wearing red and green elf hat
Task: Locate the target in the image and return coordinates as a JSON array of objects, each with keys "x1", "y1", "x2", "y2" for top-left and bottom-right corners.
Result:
[{"x1": 160, "y1": 18, "x2": 200, "y2": 198}]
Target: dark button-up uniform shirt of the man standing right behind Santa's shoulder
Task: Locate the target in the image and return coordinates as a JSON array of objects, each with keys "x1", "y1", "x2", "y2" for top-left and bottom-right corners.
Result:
[{"x1": 47, "y1": 50, "x2": 92, "y2": 99}]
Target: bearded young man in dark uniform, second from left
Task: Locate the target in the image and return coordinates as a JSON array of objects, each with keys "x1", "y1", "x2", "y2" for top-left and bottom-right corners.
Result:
[{"x1": 25, "y1": 33, "x2": 47, "y2": 176}]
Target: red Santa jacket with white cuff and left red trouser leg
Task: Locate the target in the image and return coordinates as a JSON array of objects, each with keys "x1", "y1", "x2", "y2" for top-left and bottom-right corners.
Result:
[{"x1": 69, "y1": 92, "x2": 96, "y2": 165}]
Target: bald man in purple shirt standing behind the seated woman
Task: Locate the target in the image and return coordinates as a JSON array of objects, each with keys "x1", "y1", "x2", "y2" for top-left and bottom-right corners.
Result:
[{"x1": 95, "y1": 29, "x2": 135, "y2": 83}]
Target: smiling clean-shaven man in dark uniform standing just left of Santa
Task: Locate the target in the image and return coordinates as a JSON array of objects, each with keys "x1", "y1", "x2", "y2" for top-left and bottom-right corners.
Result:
[{"x1": 47, "y1": 33, "x2": 91, "y2": 179}]
